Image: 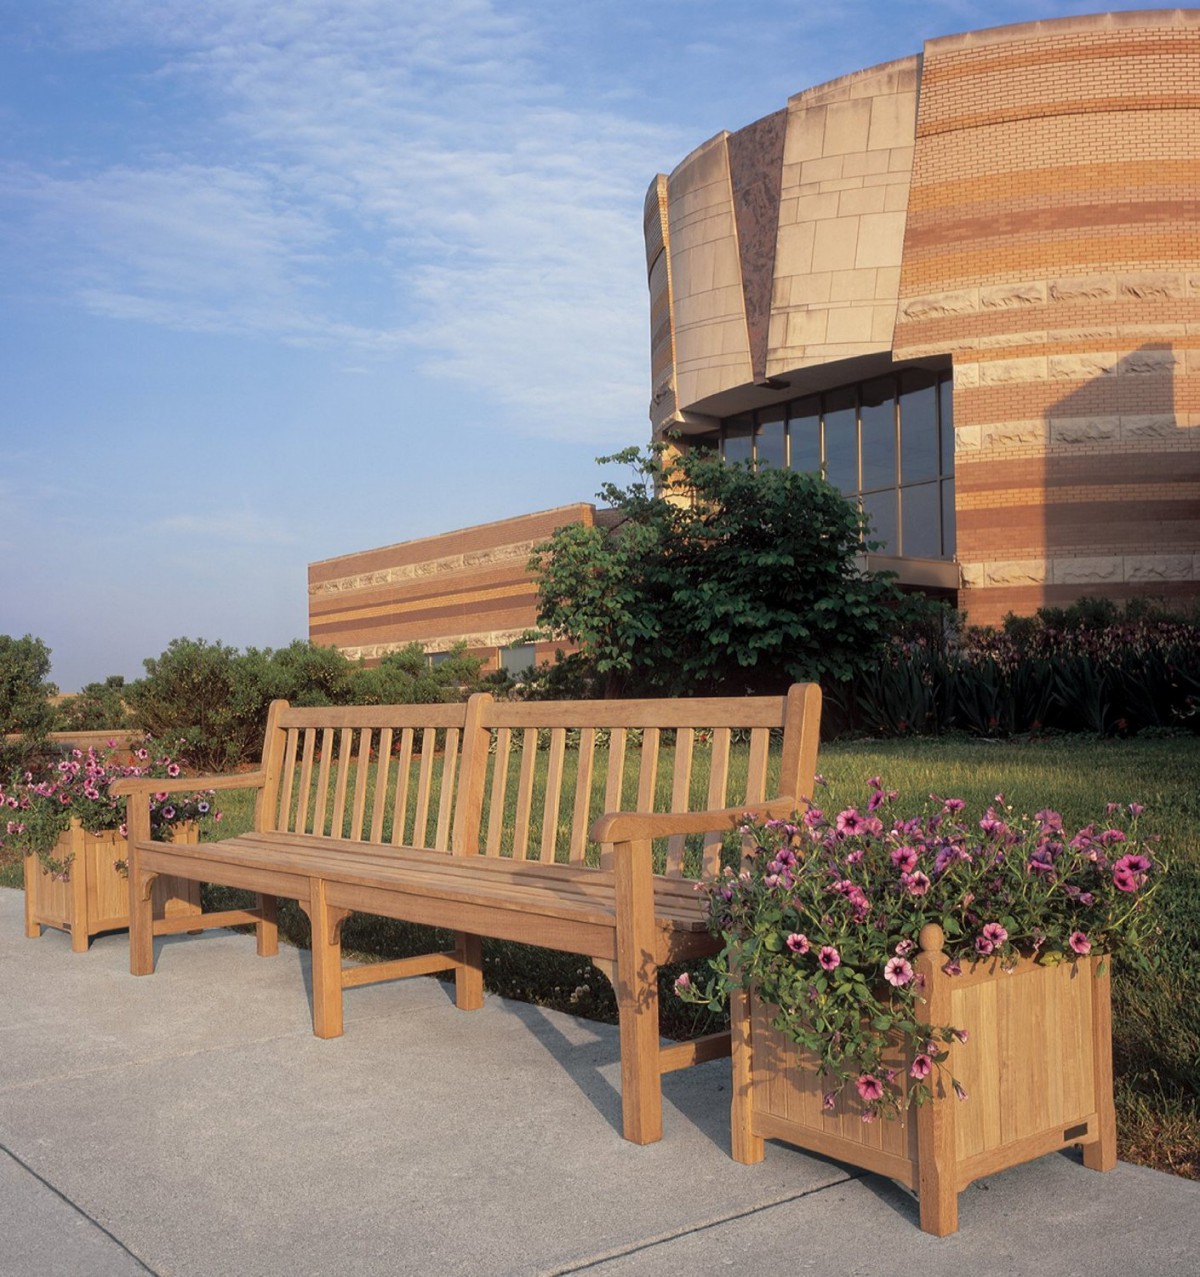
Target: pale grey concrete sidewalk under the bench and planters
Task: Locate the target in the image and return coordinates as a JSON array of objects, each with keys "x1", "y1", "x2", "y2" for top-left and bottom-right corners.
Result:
[{"x1": 0, "y1": 889, "x2": 1200, "y2": 1277}]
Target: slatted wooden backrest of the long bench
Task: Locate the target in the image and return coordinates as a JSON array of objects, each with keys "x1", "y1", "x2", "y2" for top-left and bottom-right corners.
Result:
[{"x1": 259, "y1": 683, "x2": 821, "y2": 876}]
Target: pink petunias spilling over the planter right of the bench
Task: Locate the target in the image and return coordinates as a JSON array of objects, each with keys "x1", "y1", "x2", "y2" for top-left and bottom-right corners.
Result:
[{"x1": 675, "y1": 778, "x2": 1164, "y2": 1120}]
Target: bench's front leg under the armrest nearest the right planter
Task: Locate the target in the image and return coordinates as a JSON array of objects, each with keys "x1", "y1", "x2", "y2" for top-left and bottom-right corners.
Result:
[{"x1": 614, "y1": 843, "x2": 663, "y2": 1144}]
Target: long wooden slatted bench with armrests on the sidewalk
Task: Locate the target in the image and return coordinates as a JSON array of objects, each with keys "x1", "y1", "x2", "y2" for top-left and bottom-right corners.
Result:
[{"x1": 114, "y1": 684, "x2": 821, "y2": 1144}]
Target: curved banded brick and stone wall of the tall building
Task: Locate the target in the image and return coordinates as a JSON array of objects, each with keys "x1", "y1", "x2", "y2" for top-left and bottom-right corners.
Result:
[{"x1": 647, "y1": 10, "x2": 1200, "y2": 622}]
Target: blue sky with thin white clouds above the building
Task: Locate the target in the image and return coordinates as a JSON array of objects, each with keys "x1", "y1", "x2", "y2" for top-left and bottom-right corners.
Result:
[{"x1": 0, "y1": 0, "x2": 1155, "y2": 691}]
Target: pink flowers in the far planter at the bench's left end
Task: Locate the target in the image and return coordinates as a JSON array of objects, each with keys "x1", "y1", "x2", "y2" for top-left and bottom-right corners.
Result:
[{"x1": 0, "y1": 742, "x2": 221, "y2": 877}]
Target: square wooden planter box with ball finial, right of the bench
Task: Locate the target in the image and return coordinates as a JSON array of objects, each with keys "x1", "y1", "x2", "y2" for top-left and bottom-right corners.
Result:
[{"x1": 733, "y1": 927, "x2": 1117, "y2": 1237}]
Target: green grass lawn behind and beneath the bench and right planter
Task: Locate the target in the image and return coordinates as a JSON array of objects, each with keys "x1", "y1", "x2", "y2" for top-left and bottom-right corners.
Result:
[{"x1": 0, "y1": 737, "x2": 1200, "y2": 1179}]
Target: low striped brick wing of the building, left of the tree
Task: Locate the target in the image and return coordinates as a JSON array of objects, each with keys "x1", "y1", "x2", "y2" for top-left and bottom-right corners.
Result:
[{"x1": 309, "y1": 504, "x2": 596, "y2": 668}]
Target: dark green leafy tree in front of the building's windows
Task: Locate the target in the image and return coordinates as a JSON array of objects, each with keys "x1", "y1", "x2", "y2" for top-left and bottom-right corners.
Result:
[{"x1": 531, "y1": 446, "x2": 922, "y2": 695}]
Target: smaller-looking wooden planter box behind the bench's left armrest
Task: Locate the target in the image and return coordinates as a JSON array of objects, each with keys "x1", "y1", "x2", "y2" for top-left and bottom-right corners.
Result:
[{"x1": 24, "y1": 820, "x2": 200, "y2": 953}]
